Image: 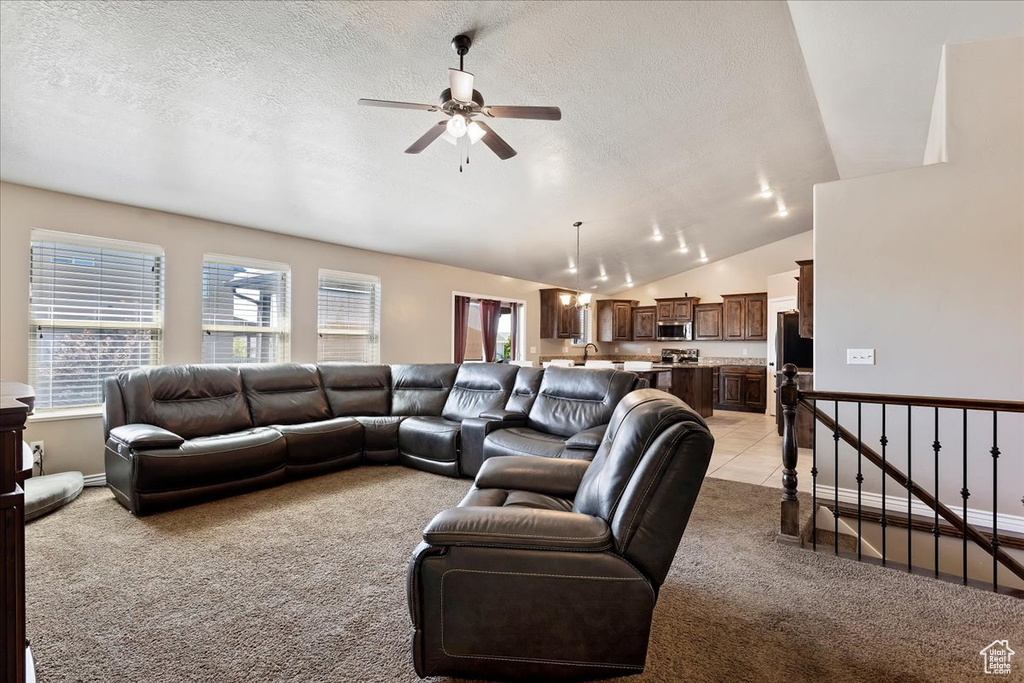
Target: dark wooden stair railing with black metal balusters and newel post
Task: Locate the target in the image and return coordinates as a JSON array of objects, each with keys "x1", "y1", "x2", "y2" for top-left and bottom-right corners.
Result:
[{"x1": 779, "y1": 364, "x2": 1024, "y2": 590}]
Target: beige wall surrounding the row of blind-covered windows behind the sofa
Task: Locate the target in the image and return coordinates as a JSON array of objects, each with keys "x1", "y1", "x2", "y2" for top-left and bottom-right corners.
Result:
[{"x1": 0, "y1": 183, "x2": 561, "y2": 474}]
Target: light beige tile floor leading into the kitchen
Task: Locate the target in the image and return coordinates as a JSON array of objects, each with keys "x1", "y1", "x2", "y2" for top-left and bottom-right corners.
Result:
[{"x1": 708, "y1": 411, "x2": 811, "y2": 488}]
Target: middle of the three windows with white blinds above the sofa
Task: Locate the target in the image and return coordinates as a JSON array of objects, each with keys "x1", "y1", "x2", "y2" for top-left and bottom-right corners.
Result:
[{"x1": 203, "y1": 254, "x2": 291, "y2": 364}]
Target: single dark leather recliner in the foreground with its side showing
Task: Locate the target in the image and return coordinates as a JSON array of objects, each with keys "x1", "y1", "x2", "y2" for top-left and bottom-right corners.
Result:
[{"x1": 409, "y1": 389, "x2": 714, "y2": 680}]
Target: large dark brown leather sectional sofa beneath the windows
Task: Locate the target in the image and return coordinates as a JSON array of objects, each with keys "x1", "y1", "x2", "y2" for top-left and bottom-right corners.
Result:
[{"x1": 103, "y1": 364, "x2": 644, "y2": 515}]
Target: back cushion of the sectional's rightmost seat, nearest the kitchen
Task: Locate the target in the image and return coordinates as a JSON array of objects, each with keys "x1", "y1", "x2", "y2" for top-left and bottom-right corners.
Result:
[{"x1": 527, "y1": 368, "x2": 637, "y2": 436}]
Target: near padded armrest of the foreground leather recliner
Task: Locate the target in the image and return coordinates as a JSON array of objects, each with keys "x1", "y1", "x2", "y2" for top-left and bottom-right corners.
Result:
[{"x1": 423, "y1": 507, "x2": 611, "y2": 552}]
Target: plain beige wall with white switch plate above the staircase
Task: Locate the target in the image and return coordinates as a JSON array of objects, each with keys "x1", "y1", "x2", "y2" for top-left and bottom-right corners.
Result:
[{"x1": 814, "y1": 38, "x2": 1024, "y2": 515}]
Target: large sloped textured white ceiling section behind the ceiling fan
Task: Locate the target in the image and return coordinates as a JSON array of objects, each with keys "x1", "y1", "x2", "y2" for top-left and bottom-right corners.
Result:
[{"x1": 0, "y1": 2, "x2": 839, "y2": 293}]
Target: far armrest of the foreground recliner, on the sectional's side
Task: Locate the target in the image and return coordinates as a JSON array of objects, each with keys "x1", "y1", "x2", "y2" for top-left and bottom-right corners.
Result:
[{"x1": 474, "y1": 456, "x2": 590, "y2": 500}]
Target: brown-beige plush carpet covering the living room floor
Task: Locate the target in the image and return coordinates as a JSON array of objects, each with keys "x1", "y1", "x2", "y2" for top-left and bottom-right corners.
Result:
[{"x1": 26, "y1": 467, "x2": 1024, "y2": 683}]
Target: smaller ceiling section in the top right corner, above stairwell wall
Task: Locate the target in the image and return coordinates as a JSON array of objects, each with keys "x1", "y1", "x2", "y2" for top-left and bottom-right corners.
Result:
[{"x1": 790, "y1": 0, "x2": 1024, "y2": 178}]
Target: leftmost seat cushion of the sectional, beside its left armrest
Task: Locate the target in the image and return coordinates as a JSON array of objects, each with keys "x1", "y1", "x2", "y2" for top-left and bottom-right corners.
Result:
[{"x1": 134, "y1": 427, "x2": 286, "y2": 492}]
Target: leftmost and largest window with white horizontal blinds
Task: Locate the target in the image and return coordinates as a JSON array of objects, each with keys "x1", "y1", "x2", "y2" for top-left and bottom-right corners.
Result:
[{"x1": 29, "y1": 230, "x2": 164, "y2": 411}]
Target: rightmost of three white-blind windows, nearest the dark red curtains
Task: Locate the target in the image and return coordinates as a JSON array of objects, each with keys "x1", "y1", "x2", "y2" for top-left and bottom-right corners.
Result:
[{"x1": 316, "y1": 270, "x2": 381, "y2": 362}]
